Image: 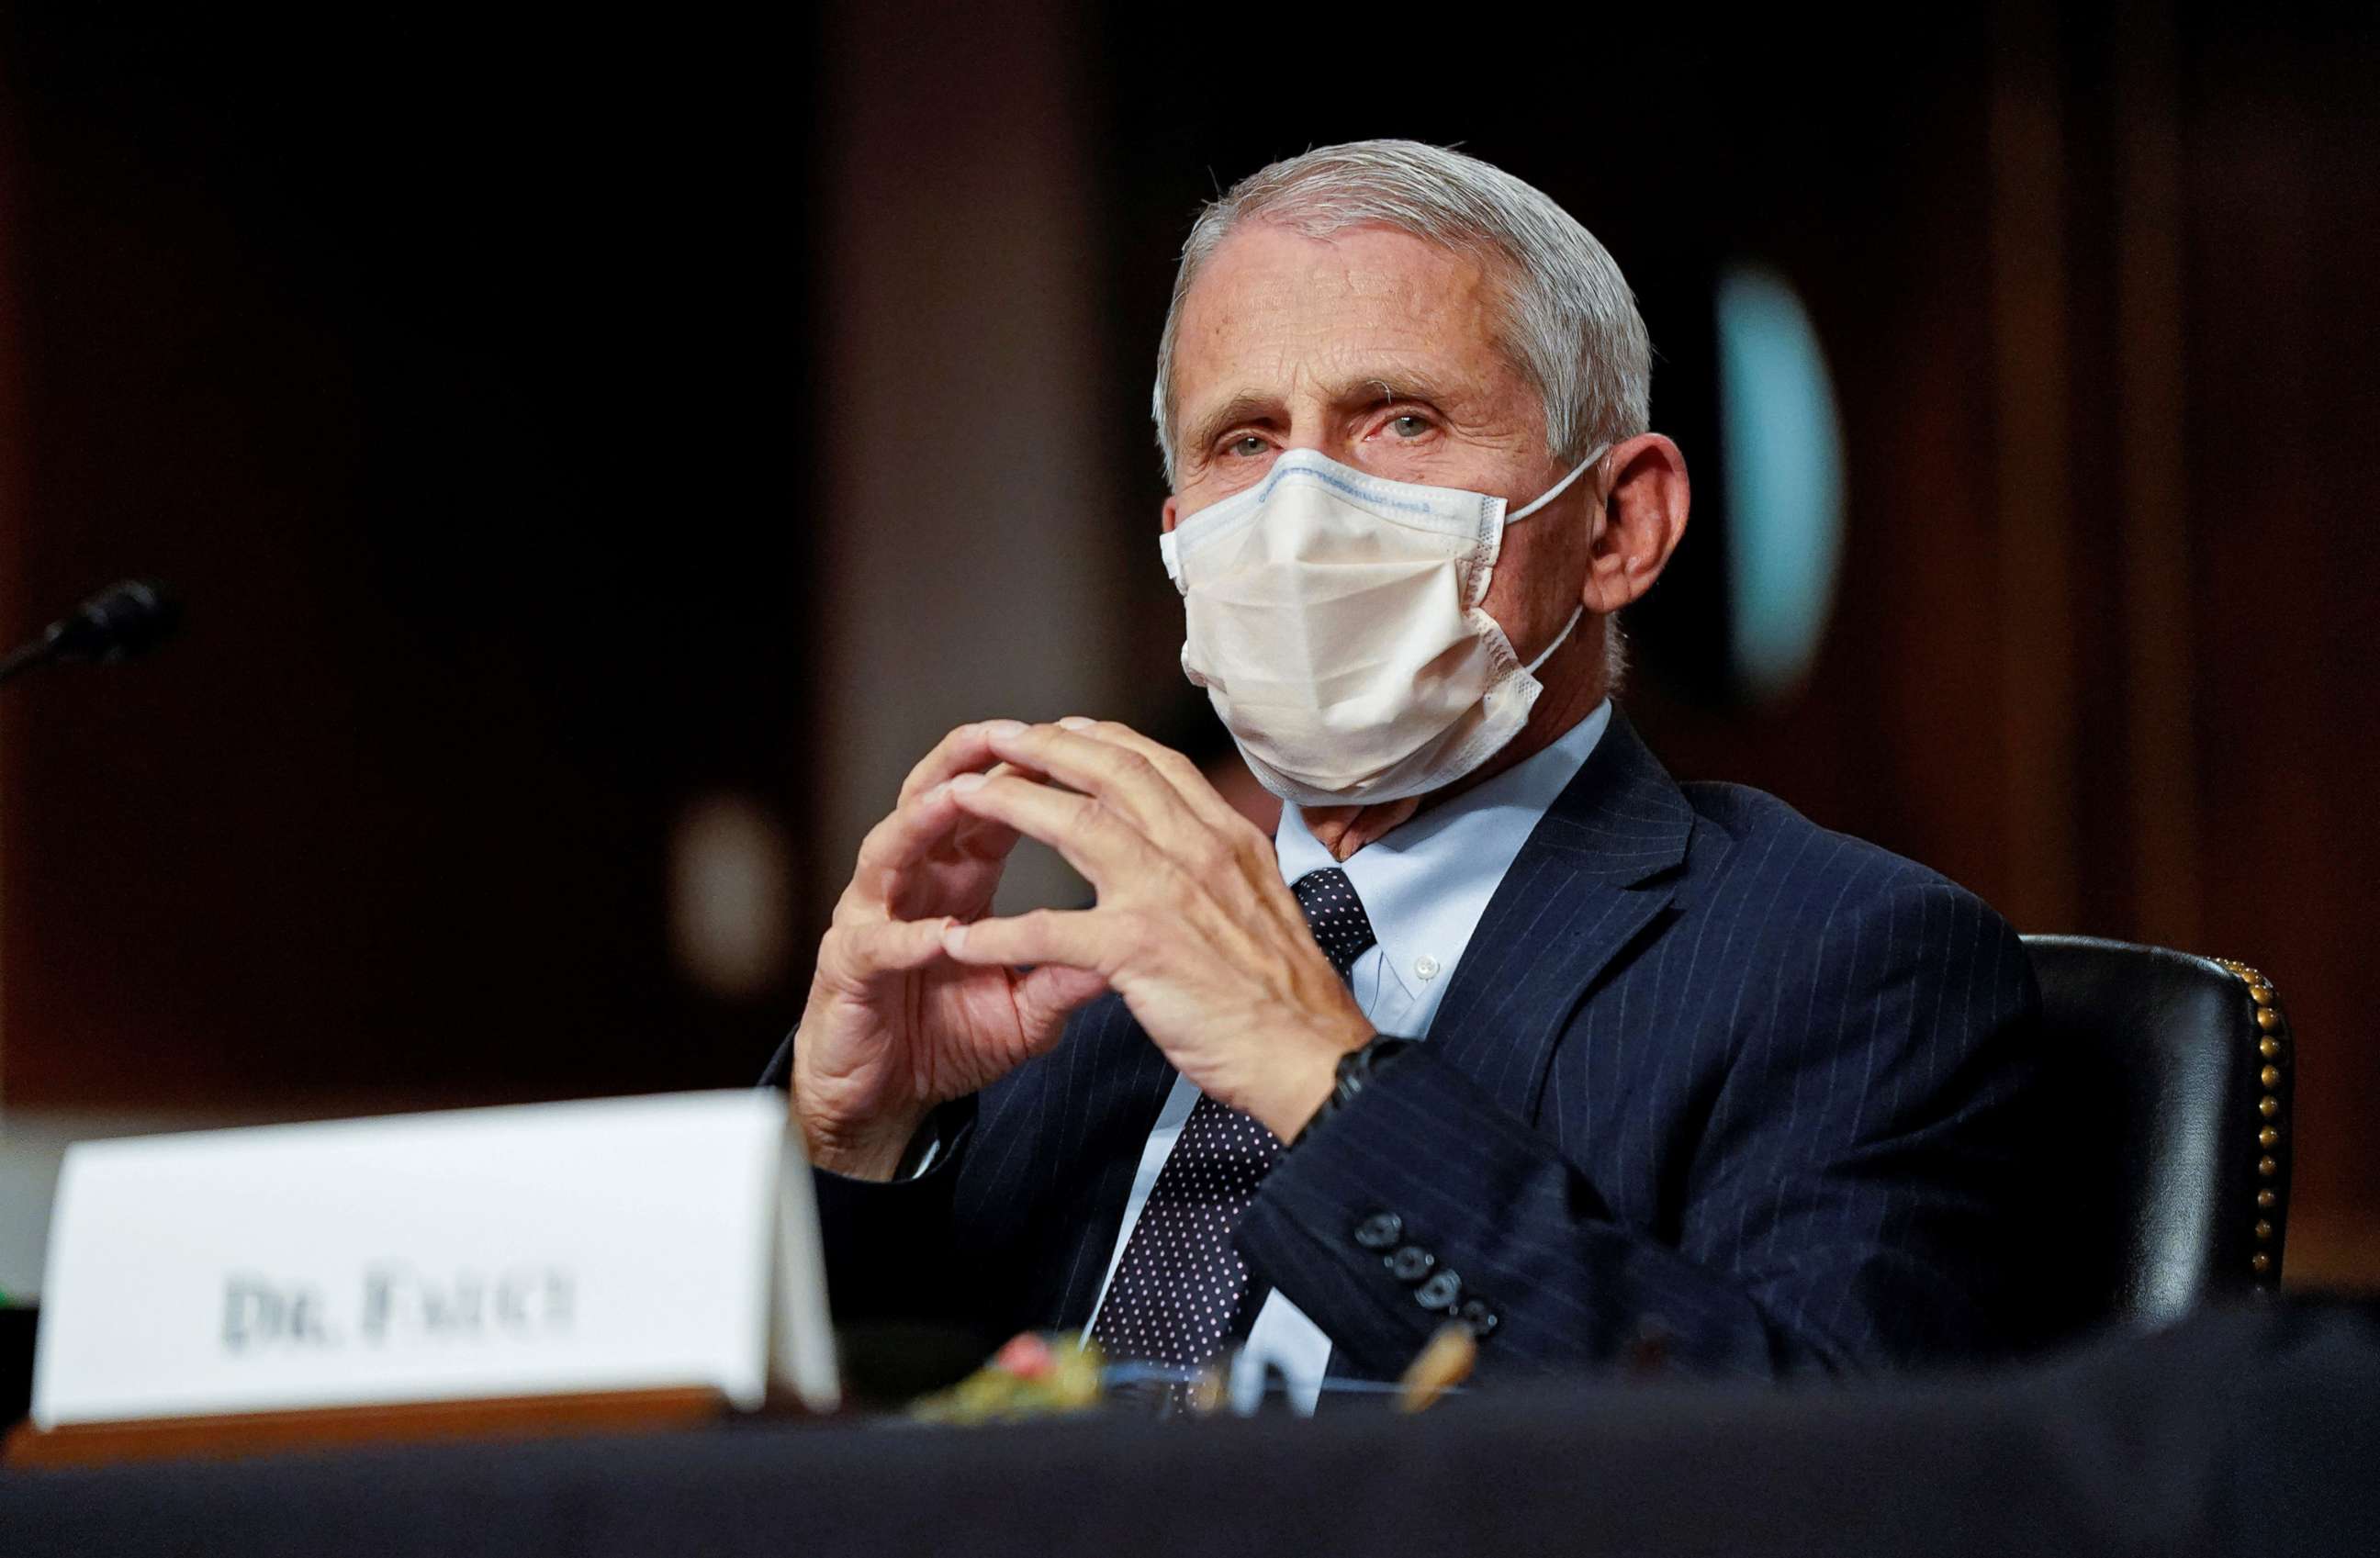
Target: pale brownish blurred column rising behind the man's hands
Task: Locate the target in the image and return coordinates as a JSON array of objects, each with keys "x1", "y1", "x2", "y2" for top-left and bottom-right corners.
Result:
[{"x1": 792, "y1": 0, "x2": 1123, "y2": 909}]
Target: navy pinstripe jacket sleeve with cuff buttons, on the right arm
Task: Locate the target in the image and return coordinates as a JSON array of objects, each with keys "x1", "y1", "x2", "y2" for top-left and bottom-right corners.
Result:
[{"x1": 1238, "y1": 878, "x2": 2039, "y2": 1377}]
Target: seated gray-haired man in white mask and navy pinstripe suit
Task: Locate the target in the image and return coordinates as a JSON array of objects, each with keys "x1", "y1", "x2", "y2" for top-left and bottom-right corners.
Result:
[{"x1": 771, "y1": 140, "x2": 2039, "y2": 1404}]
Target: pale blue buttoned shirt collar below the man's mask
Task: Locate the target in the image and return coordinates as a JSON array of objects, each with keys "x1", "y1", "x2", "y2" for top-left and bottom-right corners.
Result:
[{"x1": 1274, "y1": 700, "x2": 1611, "y2": 1006}]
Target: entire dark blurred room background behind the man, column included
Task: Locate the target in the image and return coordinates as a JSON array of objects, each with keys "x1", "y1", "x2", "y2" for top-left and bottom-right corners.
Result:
[{"x1": 0, "y1": 0, "x2": 2380, "y2": 1284}]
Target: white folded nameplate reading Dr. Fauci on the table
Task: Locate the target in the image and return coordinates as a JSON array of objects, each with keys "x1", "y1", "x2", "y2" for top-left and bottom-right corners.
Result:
[{"x1": 33, "y1": 1090, "x2": 836, "y2": 1428}]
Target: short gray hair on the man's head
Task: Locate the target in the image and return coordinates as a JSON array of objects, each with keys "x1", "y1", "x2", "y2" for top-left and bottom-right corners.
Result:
[{"x1": 1150, "y1": 140, "x2": 1652, "y2": 486}]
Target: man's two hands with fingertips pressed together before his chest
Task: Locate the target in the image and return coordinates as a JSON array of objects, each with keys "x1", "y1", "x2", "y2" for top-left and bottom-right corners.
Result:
[{"x1": 792, "y1": 718, "x2": 1371, "y2": 1177}]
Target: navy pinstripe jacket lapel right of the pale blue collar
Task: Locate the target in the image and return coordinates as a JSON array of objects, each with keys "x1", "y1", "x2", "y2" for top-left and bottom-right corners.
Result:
[{"x1": 1431, "y1": 709, "x2": 1695, "y2": 1120}]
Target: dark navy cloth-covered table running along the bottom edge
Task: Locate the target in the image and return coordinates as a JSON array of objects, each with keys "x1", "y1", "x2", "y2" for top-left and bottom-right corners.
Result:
[{"x1": 0, "y1": 1304, "x2": 2380, "y2": 1558}]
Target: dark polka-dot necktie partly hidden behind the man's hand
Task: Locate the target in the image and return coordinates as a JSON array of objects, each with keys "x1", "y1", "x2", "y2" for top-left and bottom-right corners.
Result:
[{"x1": 1090, "y1": 866, "x2": 1375, "y2": 1404}]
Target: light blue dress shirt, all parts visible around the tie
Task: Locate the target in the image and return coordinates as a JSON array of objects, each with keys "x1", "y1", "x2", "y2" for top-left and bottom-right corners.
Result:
[{"x1": 1083, "y1": 700, "x2": 1611, "y2": 1413}]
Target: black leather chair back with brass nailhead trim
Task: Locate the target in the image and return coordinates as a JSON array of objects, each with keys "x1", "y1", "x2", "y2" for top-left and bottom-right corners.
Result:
[{"x1": 2026, "y1": 935, "x2": 2296, "y2": 1325}]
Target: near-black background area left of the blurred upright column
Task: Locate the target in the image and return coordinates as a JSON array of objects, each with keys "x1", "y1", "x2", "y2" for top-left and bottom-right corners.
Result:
[{"x1": 0, "y1": 5, "x2": 816, "y2": 1104}]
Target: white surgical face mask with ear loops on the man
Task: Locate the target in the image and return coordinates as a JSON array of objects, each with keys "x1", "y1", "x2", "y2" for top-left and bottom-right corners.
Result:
[{"x1": 1159, "y1": 444, "x2": 1609, "y2": 806}]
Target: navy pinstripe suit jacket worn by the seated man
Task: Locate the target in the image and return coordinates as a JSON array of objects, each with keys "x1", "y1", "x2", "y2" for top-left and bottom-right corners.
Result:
[{"x1": 771, "y1": 713, "x2": 2051, "y2": 1377}]
